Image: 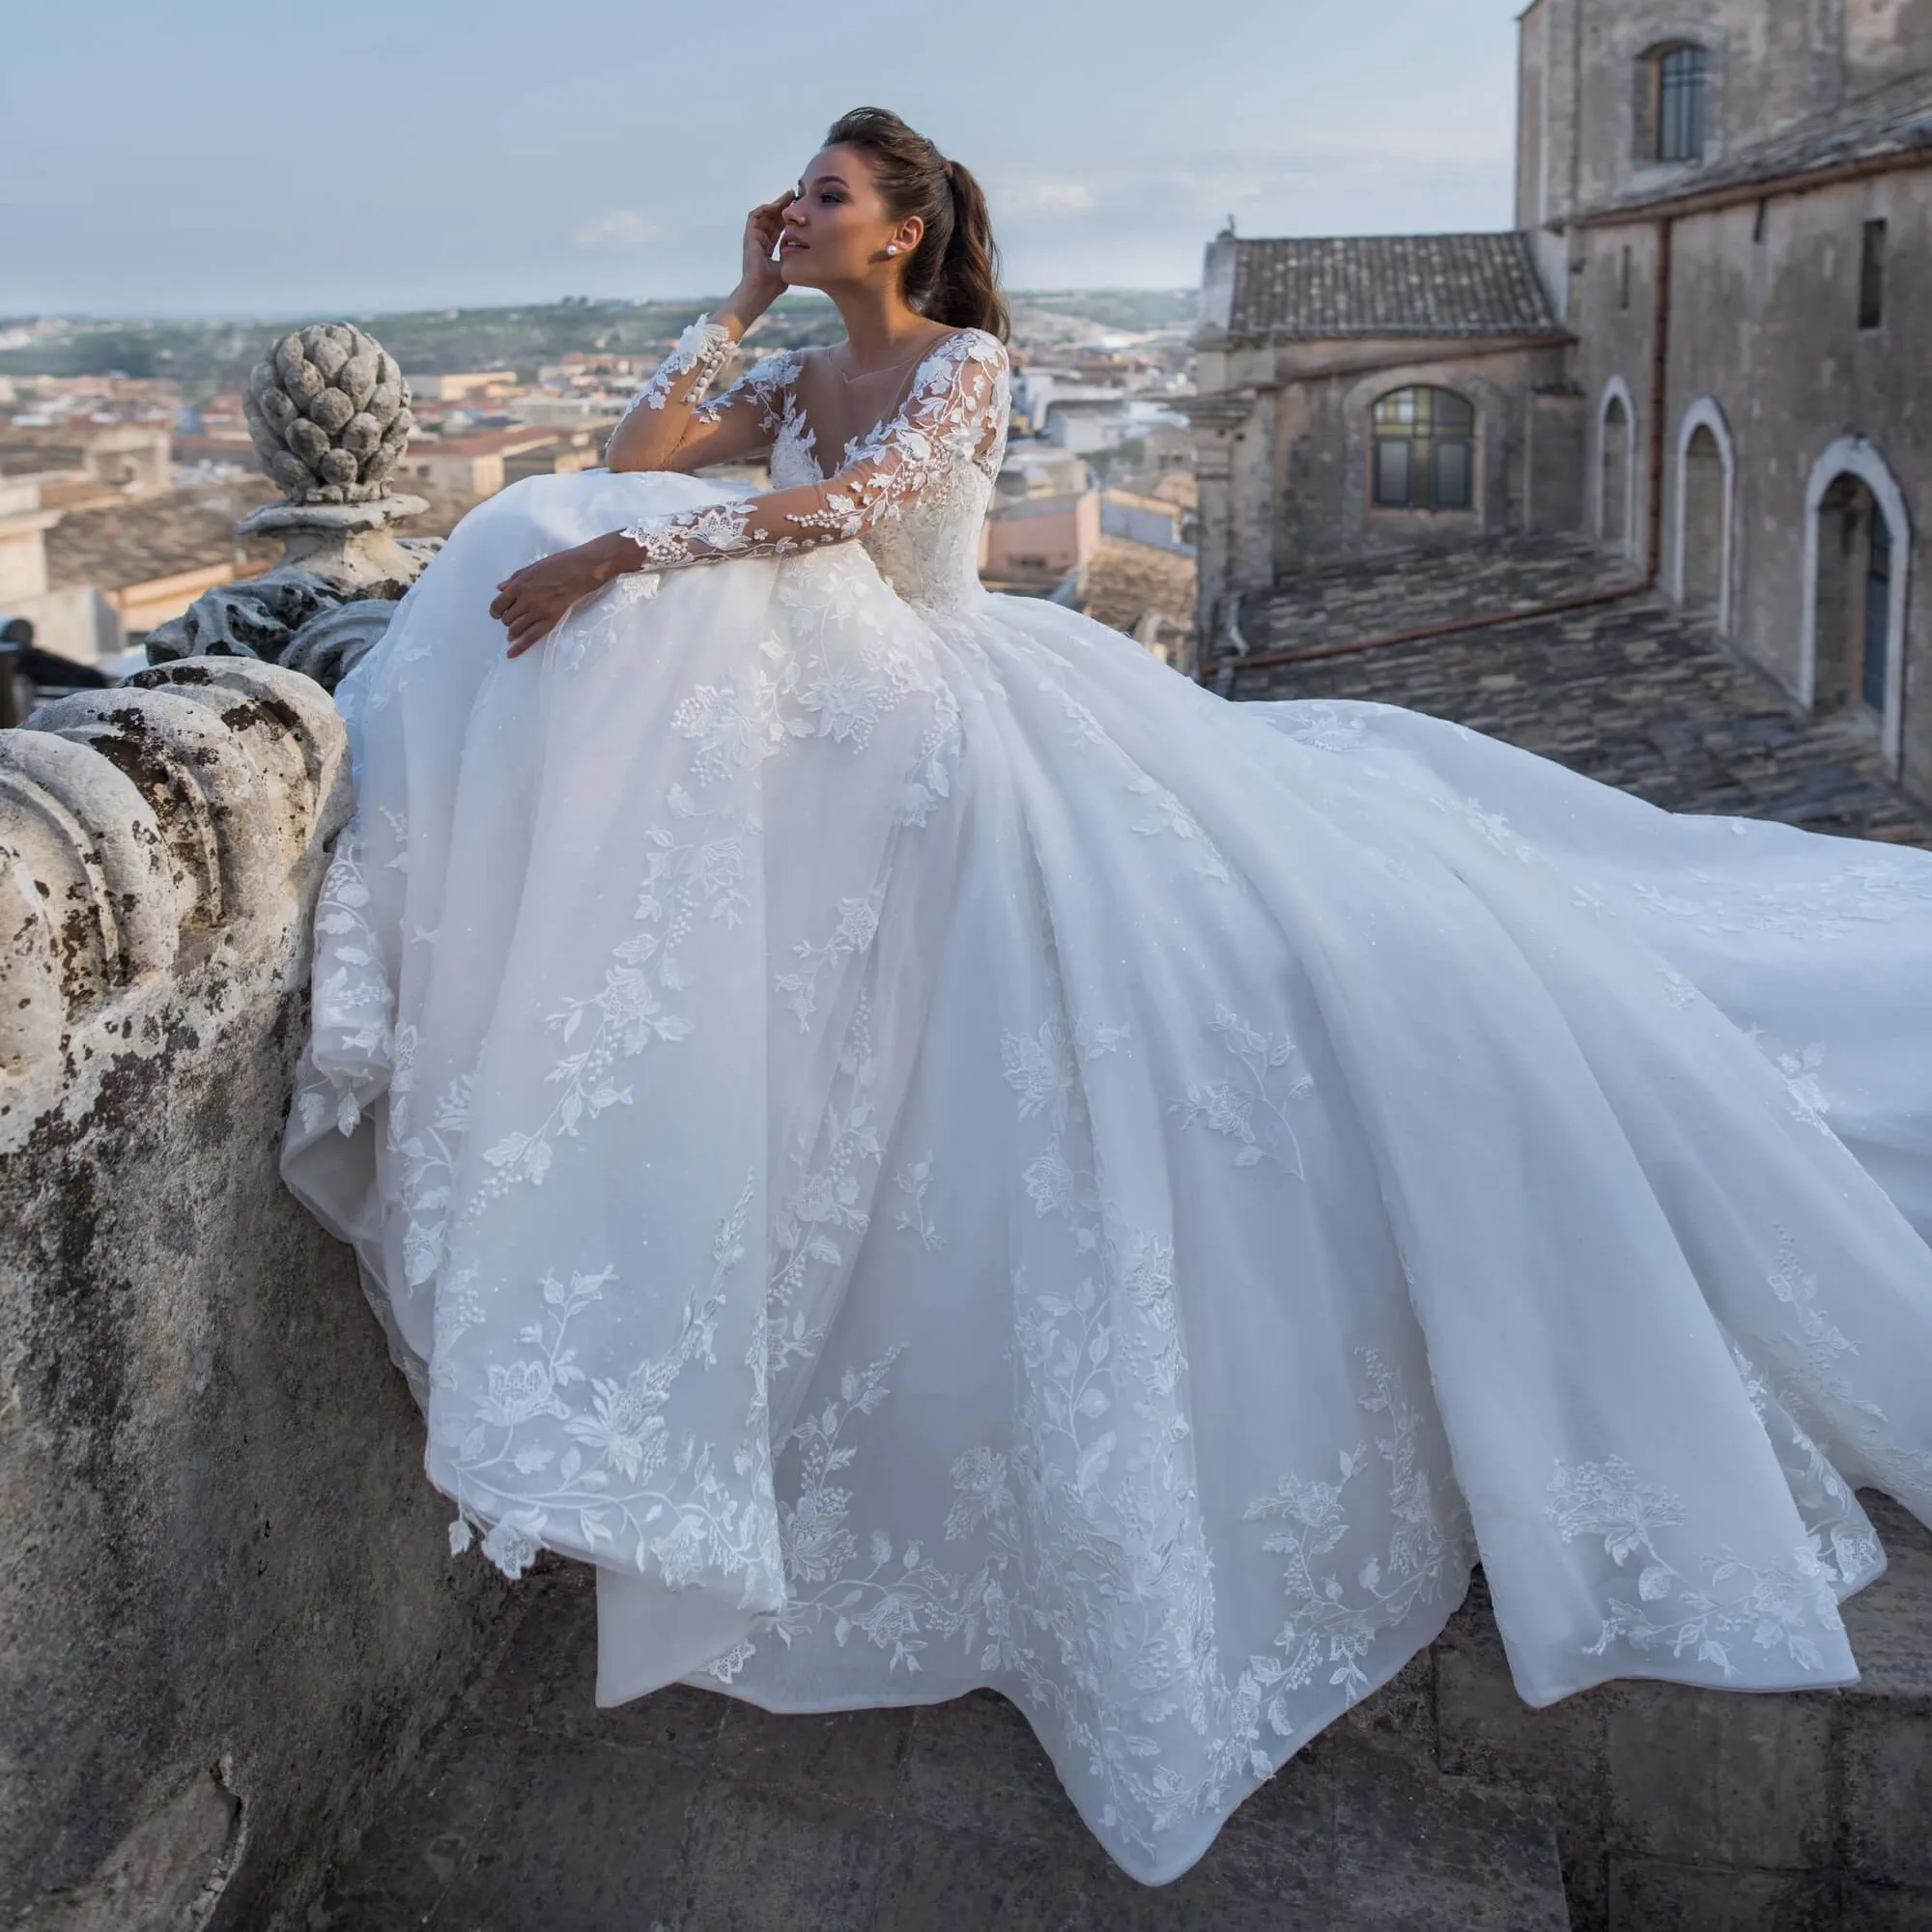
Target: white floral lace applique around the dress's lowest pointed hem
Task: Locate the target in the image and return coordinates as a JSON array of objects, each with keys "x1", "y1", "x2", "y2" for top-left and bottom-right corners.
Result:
[{"x1": 705, "y1": 1329, "x2": 1472, "y2": 1849}]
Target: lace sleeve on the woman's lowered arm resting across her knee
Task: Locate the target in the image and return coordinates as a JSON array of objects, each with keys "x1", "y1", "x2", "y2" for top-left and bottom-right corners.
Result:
[{"x1": 622, "y1": 328, "x2": 1009, "y2": 570}]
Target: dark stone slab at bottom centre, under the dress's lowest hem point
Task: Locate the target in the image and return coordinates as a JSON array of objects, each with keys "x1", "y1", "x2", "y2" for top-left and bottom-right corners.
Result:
[{"x1": 321, "y1": 1565, "x2": 1569, "y2": 1932}]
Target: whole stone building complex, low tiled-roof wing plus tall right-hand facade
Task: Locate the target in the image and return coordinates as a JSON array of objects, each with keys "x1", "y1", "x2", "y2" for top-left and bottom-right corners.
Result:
[{"x1": 1192, "y1": 0, "x2": 1932, "y2": 798}]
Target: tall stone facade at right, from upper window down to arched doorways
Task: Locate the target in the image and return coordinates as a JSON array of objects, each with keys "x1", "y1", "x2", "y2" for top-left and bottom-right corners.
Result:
[{"x1": 1546, "y1": 0, "x2": 1932, "y2": 798}]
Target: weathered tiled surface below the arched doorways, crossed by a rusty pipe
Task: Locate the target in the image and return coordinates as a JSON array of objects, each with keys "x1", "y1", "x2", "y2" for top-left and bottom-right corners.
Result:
[{"x1": 1229, "y1": 539, "x2": 1932, "y2": 846}]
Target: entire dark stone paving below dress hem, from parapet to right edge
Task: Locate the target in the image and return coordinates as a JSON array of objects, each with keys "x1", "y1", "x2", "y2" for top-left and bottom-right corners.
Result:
[{"x1": 313, "y1": 1493, "x2": 1932, "y2": 1932}]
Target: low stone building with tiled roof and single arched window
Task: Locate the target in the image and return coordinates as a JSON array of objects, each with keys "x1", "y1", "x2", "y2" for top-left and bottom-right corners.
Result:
[{"x1": 1186, "y1": 232, "x2": 1580, "y2": 611}]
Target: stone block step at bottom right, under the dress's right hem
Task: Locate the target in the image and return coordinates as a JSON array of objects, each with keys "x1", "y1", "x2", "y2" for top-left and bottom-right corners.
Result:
[{"x1": 1347, "y1": 1493, "x2": 1932, "y2": 1932}]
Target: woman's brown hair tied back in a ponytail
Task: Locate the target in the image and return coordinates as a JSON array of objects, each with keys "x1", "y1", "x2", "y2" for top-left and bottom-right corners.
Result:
[{"x1": 825, "y1": 108, "x2": 1010, "y2": 342}]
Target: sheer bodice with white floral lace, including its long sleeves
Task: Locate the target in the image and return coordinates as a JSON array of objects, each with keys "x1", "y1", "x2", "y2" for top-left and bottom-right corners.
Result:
[{"x1": 624, "y1": 317, "x2": 1010, "y2": 611}]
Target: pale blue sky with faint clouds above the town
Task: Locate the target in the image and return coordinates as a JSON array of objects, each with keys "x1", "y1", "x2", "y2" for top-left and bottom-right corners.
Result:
[{"x1": 0, "y1": 0, "x2": 1520, "y2": 317}]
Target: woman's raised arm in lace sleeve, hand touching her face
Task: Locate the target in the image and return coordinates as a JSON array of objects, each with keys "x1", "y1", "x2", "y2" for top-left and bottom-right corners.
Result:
[{"x1": 605, "y1": 189, "x2": 792, "y2": 469}]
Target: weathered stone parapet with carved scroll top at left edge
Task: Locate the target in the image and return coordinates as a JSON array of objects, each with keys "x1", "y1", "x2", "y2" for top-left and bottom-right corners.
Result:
[{"x1": 0, "y1": 657, "x2": 510, "y2": 1932}]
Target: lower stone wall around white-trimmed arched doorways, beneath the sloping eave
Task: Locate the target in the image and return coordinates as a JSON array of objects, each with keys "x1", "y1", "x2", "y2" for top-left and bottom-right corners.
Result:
[{"x1": 1577, "y1": 170, "x2": 1932, "y2": 798}]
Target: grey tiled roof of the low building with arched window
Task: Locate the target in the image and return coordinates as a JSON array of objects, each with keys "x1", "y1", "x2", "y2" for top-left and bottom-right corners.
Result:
[{"x1": 1202, "y1": 234, "x2": 1563, "y2": 340}]
